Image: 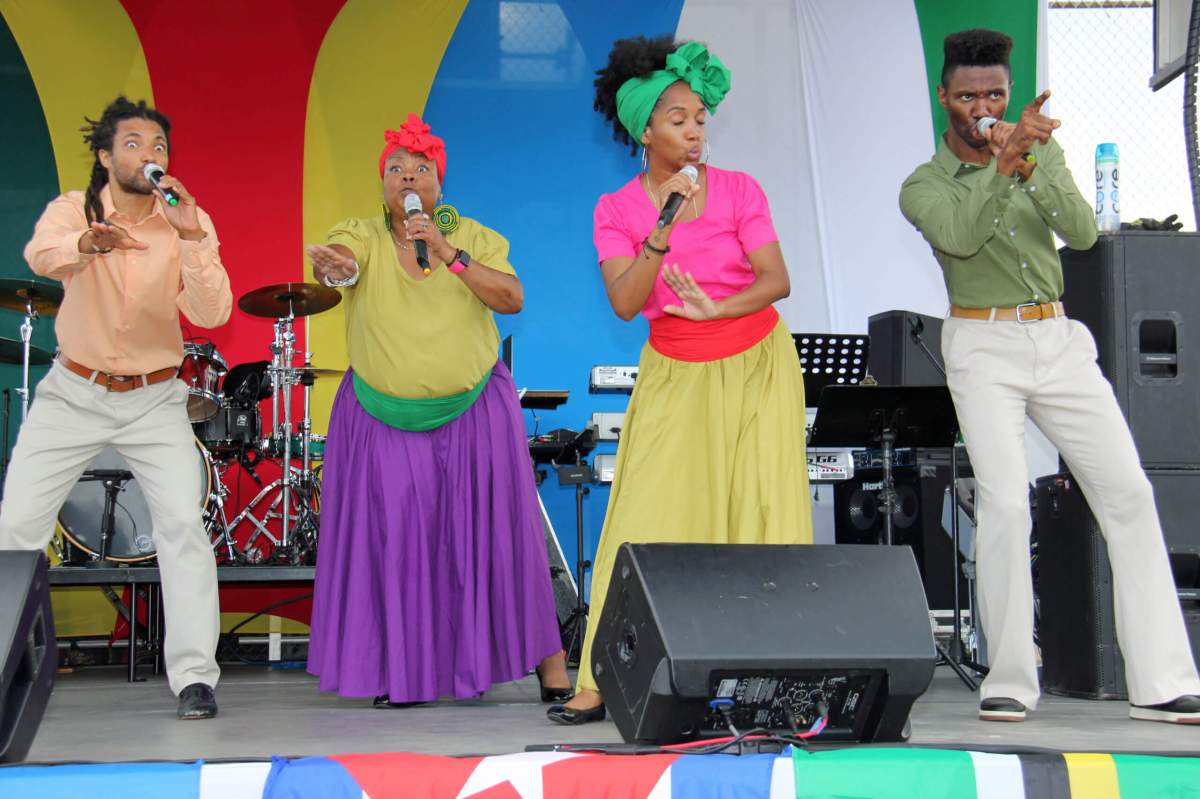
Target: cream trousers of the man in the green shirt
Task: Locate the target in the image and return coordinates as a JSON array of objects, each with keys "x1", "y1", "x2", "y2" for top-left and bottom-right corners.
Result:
[{"x1": 942, "y1": 317, "x2": 1200, "y2": 709}]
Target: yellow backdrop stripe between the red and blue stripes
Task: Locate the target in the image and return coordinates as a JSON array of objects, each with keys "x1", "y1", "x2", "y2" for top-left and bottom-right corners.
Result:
[{"x1": 298, "y1": 0, "x2": 467, "y2": 432}]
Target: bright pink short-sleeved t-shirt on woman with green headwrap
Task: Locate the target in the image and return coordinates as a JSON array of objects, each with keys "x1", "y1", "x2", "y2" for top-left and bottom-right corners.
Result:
[{"x1": 594, "y1": 166, "x2": 779, "y2": 319}]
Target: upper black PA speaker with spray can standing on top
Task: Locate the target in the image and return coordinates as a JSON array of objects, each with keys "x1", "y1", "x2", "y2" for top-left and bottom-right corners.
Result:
[{"x1": 1060, "y1": 232, "x2": 1200, "y2": 469}]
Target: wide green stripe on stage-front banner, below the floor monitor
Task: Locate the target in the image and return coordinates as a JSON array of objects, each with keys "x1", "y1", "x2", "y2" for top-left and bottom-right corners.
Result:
[{"x1": 792, "y1": 749, "x2": 979, "y2": 799}]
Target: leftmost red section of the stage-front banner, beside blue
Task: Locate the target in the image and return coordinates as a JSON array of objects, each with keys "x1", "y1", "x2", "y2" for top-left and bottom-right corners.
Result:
[{"x1": 331, "y1": 752, "x2": 484, "y2": 799}]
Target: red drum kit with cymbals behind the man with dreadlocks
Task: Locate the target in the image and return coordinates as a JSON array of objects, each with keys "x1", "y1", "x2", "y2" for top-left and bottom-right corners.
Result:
[{"x1": 0, "y1": 280, "x2": 344, "y2": 565}]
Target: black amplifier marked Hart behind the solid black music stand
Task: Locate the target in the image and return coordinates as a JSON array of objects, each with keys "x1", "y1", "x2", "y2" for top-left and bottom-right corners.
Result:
[{"x1": 833, "y1": 456, "x2": 971, "y2": 609}]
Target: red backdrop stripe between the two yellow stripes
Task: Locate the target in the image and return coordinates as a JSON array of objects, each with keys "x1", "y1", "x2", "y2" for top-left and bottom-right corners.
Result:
[{"x1": 121, "y1": 0, "x2": 344, "y2": 366}]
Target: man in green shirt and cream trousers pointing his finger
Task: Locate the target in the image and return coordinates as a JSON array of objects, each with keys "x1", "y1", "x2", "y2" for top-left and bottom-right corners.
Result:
[{"x1": 900, "y1": 30, "x2": 1200, "y2": 723}]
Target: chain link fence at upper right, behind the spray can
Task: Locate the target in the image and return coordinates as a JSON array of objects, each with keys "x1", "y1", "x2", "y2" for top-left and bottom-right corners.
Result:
[{"x1": 1041, "y1": 0, "x2": 1195, "y2": 230}]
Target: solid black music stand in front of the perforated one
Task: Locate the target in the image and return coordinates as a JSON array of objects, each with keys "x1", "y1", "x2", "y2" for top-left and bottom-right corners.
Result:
[{"x1": 809, "y1": 385, "x2": 978, "y2": 691}]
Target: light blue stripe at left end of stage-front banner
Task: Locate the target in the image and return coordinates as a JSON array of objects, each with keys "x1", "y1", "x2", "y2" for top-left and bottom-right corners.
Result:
[{"x1": 0, "y1": 763, "x2": 200, "y2": 799}]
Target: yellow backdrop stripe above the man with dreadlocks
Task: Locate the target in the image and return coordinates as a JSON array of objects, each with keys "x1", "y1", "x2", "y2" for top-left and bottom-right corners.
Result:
[{"x1": 0, "y1": 0, "x2": 154, "y2": 191}]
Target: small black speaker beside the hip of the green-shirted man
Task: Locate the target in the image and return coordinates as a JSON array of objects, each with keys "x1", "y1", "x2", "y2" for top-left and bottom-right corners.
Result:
[{"x1": 866, "y1": 311, "x2": 946, "y2": 385}]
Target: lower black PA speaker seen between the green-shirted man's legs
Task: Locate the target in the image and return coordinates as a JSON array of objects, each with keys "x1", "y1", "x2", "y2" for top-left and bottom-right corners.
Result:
[{"x1": 1037, "y1": 474, "x2": 1200, "y2": 699}]
